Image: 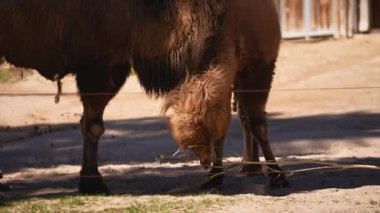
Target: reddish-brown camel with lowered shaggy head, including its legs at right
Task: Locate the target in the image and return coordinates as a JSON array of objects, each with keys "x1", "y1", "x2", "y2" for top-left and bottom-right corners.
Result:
[{"x1": 163, "y1": 1, "x2": 287, "y2": 189}]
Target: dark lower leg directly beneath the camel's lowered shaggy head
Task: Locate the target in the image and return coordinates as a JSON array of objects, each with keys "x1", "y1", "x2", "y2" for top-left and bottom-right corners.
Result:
[{"x1": 201, "y1": 138, "x2": 224, "y2": 191}]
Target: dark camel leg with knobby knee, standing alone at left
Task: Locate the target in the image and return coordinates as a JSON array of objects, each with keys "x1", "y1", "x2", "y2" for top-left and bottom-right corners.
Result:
[{"x1": 77, "y1": 60, "x2": 130, "y2": 194}]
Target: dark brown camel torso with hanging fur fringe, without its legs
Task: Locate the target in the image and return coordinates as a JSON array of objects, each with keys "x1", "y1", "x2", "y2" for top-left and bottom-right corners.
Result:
[{"x1": 0, "y1": 0, "x2": 225, "y2": 96}]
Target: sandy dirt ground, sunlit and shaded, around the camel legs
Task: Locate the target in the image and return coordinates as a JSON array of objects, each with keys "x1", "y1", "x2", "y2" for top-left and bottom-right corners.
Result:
[{"x1": 0, "y1": 34, "x2": 380, "y2": 212}]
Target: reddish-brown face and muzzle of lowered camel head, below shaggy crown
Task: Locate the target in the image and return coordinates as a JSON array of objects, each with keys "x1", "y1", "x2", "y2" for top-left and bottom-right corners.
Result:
[{"x1": 168, "y1": 113, "x2": 215, "y2": 169}]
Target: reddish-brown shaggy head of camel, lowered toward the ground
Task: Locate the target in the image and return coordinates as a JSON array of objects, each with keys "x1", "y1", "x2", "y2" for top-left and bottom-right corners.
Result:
[{"x1": 163, "y1": 67, "x2": 231, "y2": 167}]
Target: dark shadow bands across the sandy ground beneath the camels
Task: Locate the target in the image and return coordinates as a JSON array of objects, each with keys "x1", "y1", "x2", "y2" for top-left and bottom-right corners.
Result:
[{"x1": 0, "y1": 112, "x2": 380, "y2": 200}]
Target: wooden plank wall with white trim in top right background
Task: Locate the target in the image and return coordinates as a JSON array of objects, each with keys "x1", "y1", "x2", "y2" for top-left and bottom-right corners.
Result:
[{"x1": 276, "y1": 0, "x2": 380, "y2": 39}]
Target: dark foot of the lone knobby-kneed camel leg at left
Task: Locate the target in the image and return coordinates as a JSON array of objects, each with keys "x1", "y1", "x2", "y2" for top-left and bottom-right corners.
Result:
[{"x1": 79, "y1": 177, "x2": 111, "y2": 195}]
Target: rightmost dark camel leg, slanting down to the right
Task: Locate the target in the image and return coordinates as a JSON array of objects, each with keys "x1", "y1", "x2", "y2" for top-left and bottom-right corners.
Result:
[{"x1": 237, "y1": 61, "x2": 287, "y2": 186}]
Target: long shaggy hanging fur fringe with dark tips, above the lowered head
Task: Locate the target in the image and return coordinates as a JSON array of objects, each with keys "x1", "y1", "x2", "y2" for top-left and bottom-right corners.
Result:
[{"x1": 133, "y1": 0, "x2": 225, "y2": 95}]
